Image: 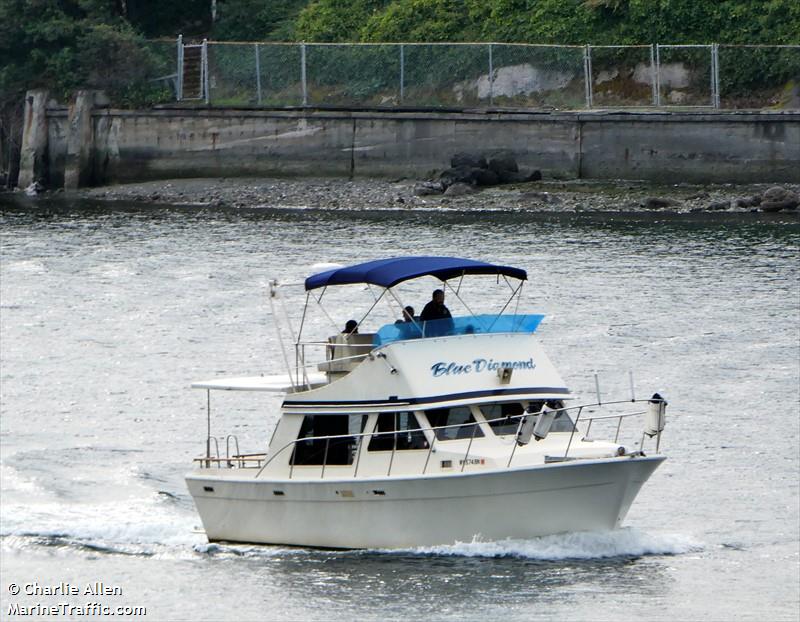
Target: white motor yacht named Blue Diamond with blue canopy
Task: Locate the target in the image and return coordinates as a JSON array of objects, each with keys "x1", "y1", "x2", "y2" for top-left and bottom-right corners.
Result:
[{"x1": 186, "y1": 257, "x2": 666, "y2": 549}]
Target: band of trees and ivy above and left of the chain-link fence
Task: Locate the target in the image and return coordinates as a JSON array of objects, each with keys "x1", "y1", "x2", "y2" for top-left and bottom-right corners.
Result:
[{"x1": 0, "y1": 0, "x2": 800, "y2": 112}]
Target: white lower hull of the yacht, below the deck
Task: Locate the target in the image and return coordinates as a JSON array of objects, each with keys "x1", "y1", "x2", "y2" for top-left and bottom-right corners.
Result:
[{"x1": 187, "y1": 456, "x2": 665, "y2": 548}]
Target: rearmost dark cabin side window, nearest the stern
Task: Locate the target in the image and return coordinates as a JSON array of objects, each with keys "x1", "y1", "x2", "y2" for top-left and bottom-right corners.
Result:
[{"x1": 291, "y1": 415, "x2": 367, "y2": 465}]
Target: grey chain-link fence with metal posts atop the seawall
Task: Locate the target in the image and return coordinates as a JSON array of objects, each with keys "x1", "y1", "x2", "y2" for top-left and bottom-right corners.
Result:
[{"x1": 173, "y1": 40, "x2": 800, "y2": 110}]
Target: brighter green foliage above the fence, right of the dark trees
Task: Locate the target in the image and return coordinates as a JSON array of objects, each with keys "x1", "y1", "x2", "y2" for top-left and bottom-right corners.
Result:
[{"x1": 295, "y1": 0, "x2": 800, "y2": 45}]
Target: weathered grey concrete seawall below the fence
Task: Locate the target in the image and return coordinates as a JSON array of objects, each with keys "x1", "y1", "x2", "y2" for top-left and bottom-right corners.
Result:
[{"x1": 32, "y1": 107, "x2": 800, "y2": 186}]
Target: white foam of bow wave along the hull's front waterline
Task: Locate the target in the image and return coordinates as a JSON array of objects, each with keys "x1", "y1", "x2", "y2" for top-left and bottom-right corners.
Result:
[{"x1": 386, "y1": 528, "x2": 703, "y2": 561}]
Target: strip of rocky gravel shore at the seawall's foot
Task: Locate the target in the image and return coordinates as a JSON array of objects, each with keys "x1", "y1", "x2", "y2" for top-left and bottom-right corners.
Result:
[{"x1": 4, "y1": 178, "x2": 800, "y2": 215}]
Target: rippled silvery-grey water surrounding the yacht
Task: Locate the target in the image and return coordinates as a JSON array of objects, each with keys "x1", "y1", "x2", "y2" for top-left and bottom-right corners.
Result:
[{"x1": 0, "y1": 199, "x2": 800, "y2": 620}]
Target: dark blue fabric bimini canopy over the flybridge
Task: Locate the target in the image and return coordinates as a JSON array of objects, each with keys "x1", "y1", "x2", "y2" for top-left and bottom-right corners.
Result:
[{"x1": 306, "y1": 257, "x2": 528, "y2": 291}]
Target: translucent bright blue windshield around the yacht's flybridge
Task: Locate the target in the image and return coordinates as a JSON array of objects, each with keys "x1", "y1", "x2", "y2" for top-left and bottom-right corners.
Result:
[{"x1": 372, "y1": 315, "x2": 544, "y2": 346}]
